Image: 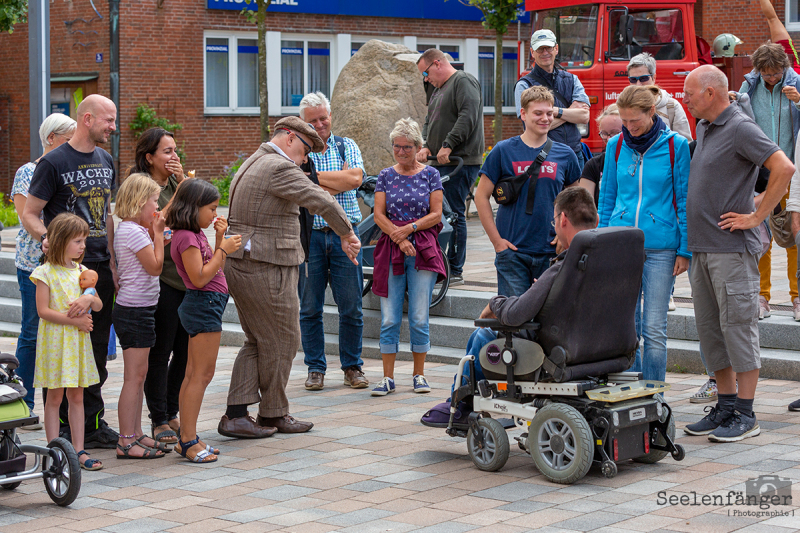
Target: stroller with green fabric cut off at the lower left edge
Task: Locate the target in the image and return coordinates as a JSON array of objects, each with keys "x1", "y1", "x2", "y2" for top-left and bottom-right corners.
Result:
[{"x1": 0, "y1": 353, "x2": 81, "y2": 507}]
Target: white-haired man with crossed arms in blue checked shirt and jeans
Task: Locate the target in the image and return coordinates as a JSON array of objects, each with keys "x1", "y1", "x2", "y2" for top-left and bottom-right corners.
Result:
[{"x1": 299, "y1": 92, "x2": 369, "y2": 390}]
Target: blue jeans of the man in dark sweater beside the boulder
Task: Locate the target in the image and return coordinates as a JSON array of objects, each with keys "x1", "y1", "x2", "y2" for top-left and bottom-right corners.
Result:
[{"x1": 436, "y1": 165, "x2": 481, "y2": 276}]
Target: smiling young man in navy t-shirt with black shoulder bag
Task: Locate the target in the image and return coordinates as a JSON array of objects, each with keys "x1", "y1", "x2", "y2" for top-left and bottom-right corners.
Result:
[{"x1": 475, "y1": 85, "x2": 581, "y2": 296}]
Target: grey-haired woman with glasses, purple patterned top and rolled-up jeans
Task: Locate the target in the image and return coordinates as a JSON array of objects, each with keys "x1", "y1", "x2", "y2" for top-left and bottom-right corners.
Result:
[{"x1": 372, "y1": 118, "x2": 446, "y2": 396}]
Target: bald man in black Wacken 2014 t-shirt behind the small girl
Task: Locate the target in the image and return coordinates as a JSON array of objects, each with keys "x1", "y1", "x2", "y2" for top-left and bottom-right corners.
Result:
[{"x1": 22, "y1": 94, "x2": 119, "y2": 448}]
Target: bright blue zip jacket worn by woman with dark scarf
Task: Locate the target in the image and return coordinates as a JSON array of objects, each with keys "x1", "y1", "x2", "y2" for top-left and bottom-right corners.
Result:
[{"x1": 598, "y1": 130, "x2": 692, "y2": 258}]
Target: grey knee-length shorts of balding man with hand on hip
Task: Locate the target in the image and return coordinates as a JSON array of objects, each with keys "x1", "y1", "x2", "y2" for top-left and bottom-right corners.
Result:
[{"x1": 690, "y1": 252, "x2": 761, "y2": 372}]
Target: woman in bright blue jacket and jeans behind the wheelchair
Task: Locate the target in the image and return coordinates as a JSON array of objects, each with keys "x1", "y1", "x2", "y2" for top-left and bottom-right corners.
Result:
[{"x1": 598, "y1": 85, "x2": 691, "y2": 381}]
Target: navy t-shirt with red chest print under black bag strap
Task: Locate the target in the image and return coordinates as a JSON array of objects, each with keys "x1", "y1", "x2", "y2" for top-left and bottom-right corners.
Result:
[{"x1": 480, "y1": 137, "x2": 581, "y2": 254}]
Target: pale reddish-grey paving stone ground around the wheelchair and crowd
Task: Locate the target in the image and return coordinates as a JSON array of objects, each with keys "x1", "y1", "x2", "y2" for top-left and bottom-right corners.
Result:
[{"x1": 0, "y1": 338, "x2": 800, "y2": 533}]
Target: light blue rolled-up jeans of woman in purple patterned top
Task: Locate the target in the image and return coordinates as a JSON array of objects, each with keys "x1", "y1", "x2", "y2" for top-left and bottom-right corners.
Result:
[{"x1": 380, "y1": 256, "x2": 437, "y2": 354}]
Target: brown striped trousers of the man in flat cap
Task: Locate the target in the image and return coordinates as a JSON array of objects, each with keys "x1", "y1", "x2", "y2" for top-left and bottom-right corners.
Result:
[{"x1": 225, "y1": 252, "x2": 300, "y2": 418}]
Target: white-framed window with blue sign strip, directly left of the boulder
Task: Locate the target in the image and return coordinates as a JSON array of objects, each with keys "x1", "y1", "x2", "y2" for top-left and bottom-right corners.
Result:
[{"x1": 281, "y1": 39, "x2": 331, "y2": 112}]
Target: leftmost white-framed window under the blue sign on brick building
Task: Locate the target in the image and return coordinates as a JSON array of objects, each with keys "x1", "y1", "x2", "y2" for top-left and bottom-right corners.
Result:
[{"x1": 205, "y1": 34, "x2": 259, "y2": 114}]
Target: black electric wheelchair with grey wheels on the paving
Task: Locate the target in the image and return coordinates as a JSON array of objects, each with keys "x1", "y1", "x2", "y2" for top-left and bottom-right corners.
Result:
[{"x1": 447, "y1": 228, "x2": 684, "y2": 484}]
